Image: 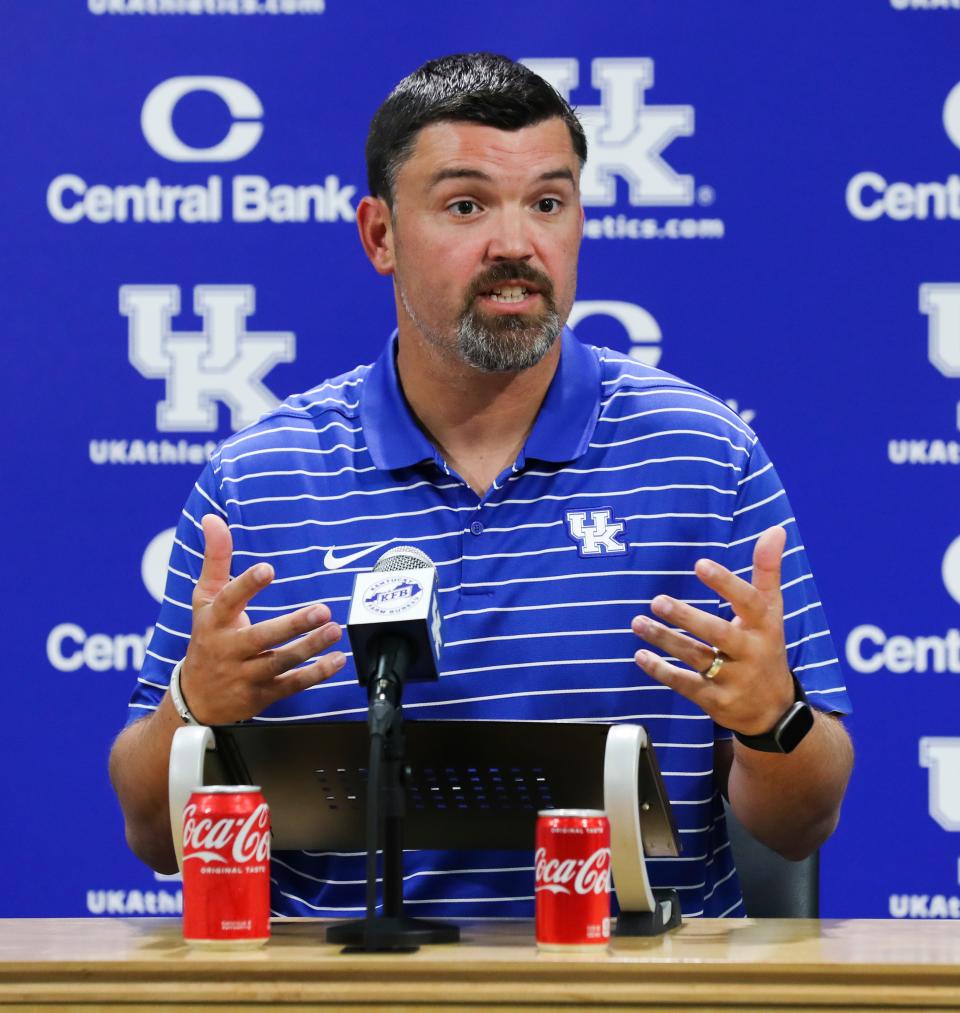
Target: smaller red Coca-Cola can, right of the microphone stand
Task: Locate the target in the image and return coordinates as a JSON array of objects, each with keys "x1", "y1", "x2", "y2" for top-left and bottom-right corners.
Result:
[{"x1": 534, "y1": 809, "x2": 610, "y2": 950}]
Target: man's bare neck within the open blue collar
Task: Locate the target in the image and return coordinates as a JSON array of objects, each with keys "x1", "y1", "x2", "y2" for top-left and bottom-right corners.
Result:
[{"x1": 397, "y1": 325, "x2": 560, "y2": 496}]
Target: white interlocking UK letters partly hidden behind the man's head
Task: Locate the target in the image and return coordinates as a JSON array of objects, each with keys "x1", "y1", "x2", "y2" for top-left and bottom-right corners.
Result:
[{"x1": 523, "y1": 58, "x2": 695, "y2": 208}]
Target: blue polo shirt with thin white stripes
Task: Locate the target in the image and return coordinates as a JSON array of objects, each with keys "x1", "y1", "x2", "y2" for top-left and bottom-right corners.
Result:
[{"x1": 131, "y1": 330, "x2": 850, "y2": 919}]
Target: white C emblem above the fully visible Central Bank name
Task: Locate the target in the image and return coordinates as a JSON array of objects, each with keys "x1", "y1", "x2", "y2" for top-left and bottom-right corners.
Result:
[{"x1": 140, "y1": 77, "x2": 263, "y2": 162}]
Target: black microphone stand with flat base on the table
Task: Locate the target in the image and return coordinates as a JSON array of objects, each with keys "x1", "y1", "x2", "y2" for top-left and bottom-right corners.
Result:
[{"x1": 327, "y1": 634, "x2": 460, "y2": 953}]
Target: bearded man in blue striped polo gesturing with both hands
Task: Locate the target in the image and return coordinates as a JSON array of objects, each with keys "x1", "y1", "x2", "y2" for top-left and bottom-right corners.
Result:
[{"x1": 111, "y1": 55, "x2": 852, "y2": 918}]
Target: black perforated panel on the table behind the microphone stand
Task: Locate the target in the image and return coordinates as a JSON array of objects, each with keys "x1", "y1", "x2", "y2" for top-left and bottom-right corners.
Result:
[{"x1": 208, "y1": 721, "x2": 677, "y2": 854}]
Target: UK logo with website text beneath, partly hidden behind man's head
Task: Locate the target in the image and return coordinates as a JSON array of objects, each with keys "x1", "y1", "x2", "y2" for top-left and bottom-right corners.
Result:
[{"x1": 523, "y1": 57, "x2": 724, "y2": 239}]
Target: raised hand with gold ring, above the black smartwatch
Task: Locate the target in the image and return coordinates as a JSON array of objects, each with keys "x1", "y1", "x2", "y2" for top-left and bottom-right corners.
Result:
[{"x1": 633, "y1": 528, "x2": 794, "y2": 735}]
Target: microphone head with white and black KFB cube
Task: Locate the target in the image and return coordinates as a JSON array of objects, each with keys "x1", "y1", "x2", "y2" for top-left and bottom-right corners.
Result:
[{"x1": 346, "y1": 545, "x2": 444, "y2": 686}]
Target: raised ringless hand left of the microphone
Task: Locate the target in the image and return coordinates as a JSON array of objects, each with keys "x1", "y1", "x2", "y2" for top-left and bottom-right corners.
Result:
[{"x1": 180, "y1": 514, "x2": 345, "y2": 724}]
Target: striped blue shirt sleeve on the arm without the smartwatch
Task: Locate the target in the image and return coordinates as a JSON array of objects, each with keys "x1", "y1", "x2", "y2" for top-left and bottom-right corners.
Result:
[{"x1": 127, "y1": 465, "x2": 227, "y2": 724}]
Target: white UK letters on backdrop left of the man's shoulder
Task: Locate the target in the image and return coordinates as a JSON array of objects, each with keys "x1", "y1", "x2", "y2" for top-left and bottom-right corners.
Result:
[{"x1": 119, "y1": 285, "x2": 297, "y2": 433}]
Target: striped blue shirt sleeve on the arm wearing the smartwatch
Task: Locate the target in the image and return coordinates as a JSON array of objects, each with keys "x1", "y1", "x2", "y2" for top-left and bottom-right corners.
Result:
[{"x1": 720, "y1": 442, "x2": 852, "y2": 714}]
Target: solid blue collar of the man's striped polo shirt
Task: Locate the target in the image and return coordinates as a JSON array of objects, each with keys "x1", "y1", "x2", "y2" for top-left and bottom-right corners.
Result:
[{"x1": 359, "y1": 327, "x2": 601, "y2": 470}]
